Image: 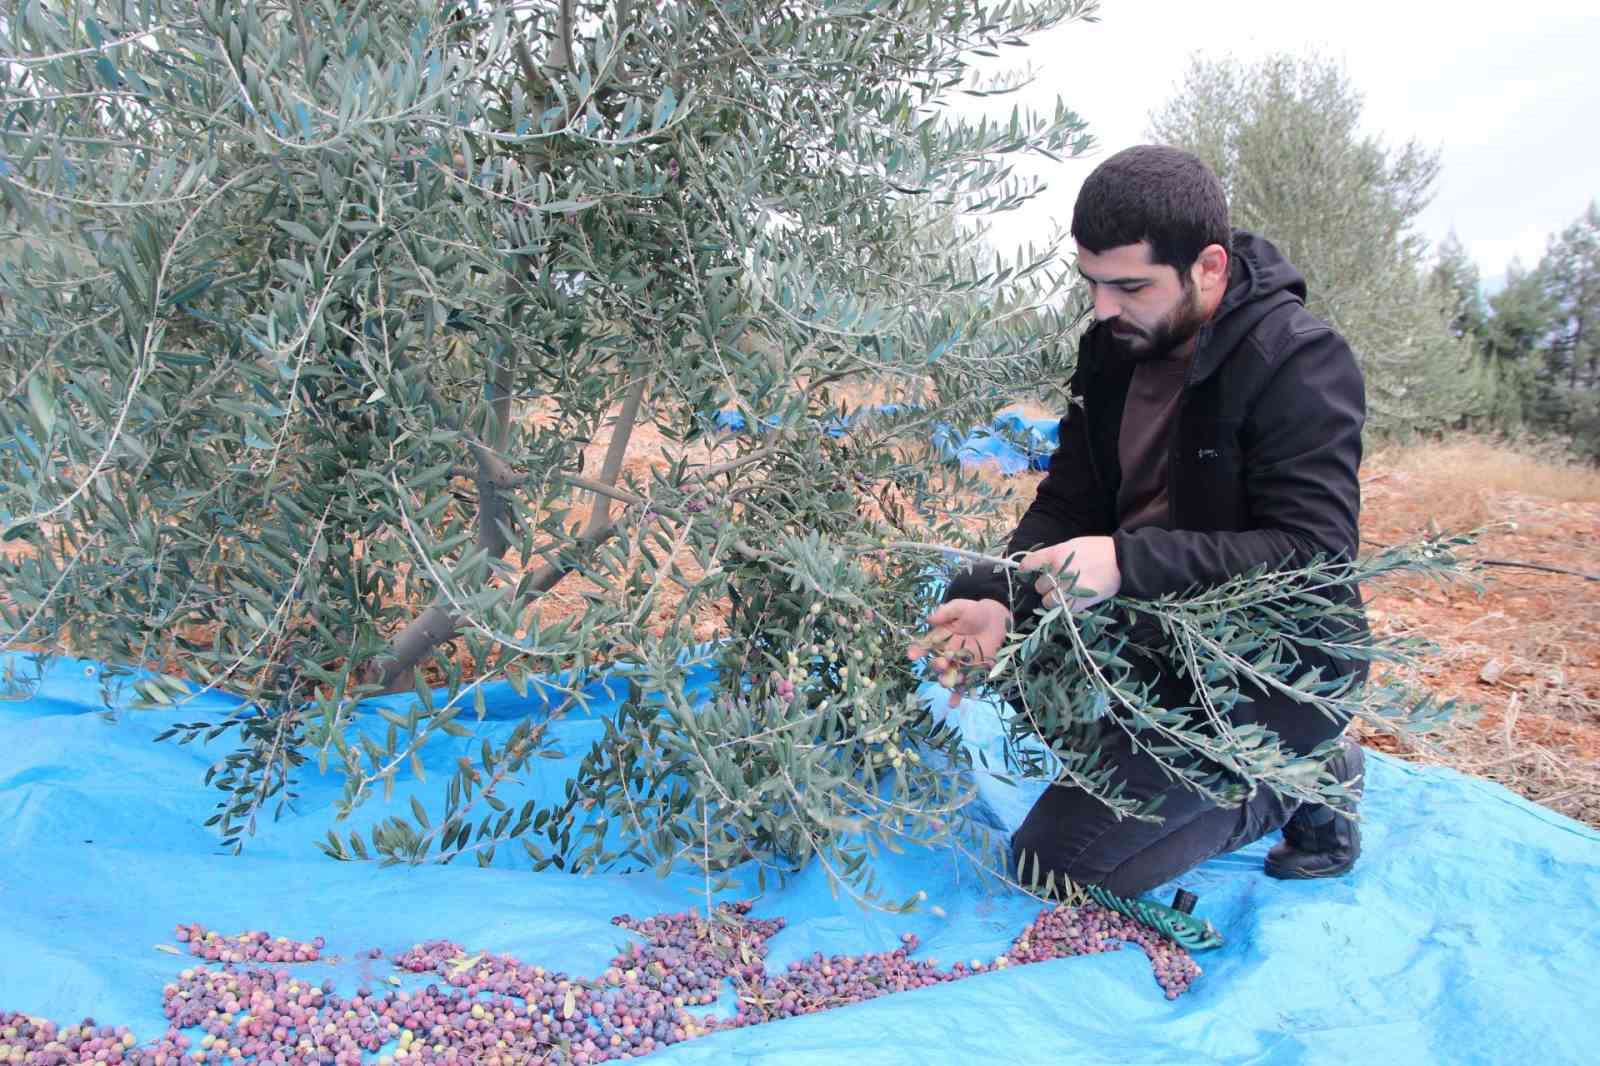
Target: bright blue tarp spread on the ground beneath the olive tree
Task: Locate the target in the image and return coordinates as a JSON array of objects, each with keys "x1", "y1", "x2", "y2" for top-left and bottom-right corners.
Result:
[{"x1": 0, "y1": 643, "x2": 1600, "y2": 1066}]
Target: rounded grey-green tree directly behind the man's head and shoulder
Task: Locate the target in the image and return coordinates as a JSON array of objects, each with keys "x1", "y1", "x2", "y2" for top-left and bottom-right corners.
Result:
[{"x1": 1150, "y1": 54, "x2": 1469, "y2": 431}]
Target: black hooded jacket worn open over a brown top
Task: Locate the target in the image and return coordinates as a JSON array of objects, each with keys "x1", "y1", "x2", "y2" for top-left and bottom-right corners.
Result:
[{"x1": 944, "y1": 230, "x2": 1365, "y2": 752}]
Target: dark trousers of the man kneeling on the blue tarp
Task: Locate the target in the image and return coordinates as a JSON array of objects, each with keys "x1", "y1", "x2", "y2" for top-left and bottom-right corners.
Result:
[{"x1": 1011, "y1": 713, "x2": 1298, "y2": 896}]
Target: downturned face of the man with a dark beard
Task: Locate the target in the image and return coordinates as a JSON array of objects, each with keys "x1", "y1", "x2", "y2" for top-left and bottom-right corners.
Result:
[{"x1": 1078, "y1": 240, "x2": 1206, "y2": 359}]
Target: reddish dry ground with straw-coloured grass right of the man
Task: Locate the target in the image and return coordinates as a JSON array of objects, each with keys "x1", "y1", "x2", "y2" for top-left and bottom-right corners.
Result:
[{"x1": 1362, "y1": 442, "x2": 1600, "y2": 826}]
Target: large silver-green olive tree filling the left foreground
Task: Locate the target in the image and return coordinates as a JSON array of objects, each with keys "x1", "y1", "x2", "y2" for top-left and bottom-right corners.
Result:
[{"x1": 0, "y1": 0, "x2": 1452, "y2": 892}]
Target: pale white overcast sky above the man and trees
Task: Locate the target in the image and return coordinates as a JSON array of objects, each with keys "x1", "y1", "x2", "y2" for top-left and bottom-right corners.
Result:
[{"x1": 953, "y1": 0, "x2": 1600, "y2": 280}]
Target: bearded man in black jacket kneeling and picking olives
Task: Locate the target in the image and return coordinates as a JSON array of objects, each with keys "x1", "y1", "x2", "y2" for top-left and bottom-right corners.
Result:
[{"x1": 914, "y1": 146, "x2": 1366, "y2": 896}]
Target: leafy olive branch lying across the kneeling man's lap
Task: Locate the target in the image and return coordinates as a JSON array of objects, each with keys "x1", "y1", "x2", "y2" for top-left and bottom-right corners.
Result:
[{"x1": 987, "y1": 536, "x2": 1469, "y2": 820}]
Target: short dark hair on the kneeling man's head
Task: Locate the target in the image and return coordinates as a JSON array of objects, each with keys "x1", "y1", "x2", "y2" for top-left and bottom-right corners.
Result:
[{"x1": 1072, "y1": 144, "x2": 1232, "y2": 270}]
